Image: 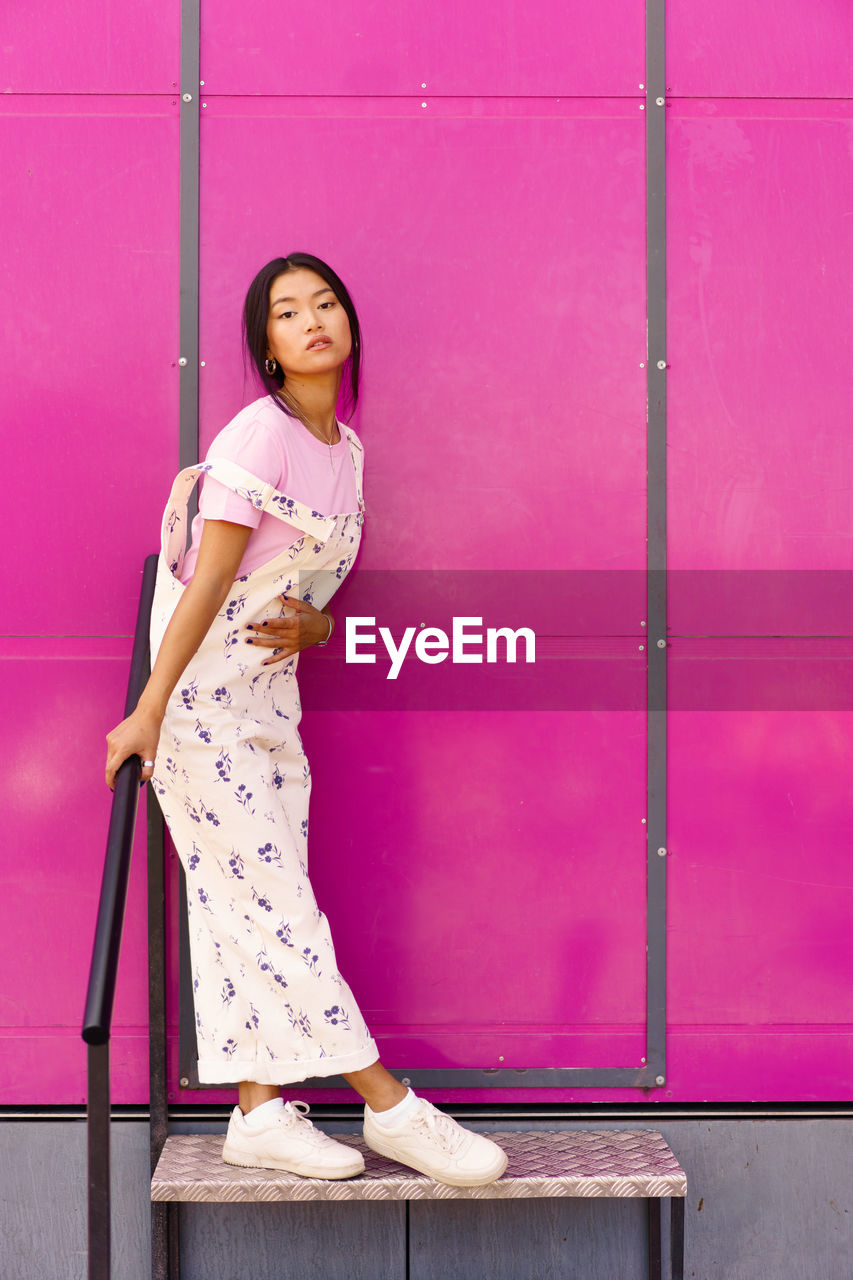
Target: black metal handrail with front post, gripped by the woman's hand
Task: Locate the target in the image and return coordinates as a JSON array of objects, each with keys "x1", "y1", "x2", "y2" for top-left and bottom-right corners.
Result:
[{"x1": 82, "y1": 556, "x2": 158, "y2": 1280}]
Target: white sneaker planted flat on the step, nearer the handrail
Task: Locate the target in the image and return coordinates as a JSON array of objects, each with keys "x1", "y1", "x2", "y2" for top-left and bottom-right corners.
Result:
[{"x1": 222, "y1": 1102, "x2": 364, "y2": 1178}]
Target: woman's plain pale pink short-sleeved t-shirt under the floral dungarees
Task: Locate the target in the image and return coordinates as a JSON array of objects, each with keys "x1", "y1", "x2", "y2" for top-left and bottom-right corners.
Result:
[{"x1": 181, "y1": 396, "x2": 359, "y2": 584}]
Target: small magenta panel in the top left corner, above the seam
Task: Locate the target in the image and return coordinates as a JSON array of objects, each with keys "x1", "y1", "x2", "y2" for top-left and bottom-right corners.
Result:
[{"x1": 0, "y1": 0, "x2": 181, "y2": 94}]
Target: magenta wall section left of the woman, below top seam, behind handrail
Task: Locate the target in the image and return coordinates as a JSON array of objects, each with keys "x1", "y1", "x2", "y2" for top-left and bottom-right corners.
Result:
[{"x1": 0, "y1": 95, "x2": 178, "y2": 1103}]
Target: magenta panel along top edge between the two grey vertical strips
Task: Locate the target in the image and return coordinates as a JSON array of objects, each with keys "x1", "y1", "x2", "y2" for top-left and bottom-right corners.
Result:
[{"x1": 201, "y1": 0, "x2": 637, "y2": 99}]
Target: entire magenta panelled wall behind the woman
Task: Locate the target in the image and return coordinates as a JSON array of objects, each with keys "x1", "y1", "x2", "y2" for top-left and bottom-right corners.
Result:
[{"x1": 0, "y1": 0, "x2": 853, "y2": 1103}]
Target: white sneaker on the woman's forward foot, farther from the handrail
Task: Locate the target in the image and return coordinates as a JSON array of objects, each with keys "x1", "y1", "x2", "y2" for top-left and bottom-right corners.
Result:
[{"x1": 364, "y1": 1098, "x2": 507, "y2": 1187}]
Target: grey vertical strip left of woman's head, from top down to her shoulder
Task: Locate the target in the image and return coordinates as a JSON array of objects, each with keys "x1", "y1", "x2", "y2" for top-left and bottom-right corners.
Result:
[{"x1": 178, "y1": 0, "x2": 200, "y2": 468}]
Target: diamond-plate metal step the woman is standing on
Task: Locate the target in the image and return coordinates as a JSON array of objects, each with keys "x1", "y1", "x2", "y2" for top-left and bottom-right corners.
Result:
[{"x1": 151, "y1": 1130, "x2": 686, "y2": 1202}]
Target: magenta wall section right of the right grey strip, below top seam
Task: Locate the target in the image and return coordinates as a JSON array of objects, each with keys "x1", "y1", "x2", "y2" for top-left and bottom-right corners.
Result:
[{"x1": 666, "y1": 99, "x2": 853, "y2": 1100}]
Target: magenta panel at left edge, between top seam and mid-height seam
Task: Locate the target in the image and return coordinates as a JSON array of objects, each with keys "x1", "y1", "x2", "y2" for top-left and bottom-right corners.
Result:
[{"x1": 0, "y1": 97, "x2": 178, "y2": 635}]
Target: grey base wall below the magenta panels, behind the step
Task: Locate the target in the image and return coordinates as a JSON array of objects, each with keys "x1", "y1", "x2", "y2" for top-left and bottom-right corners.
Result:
[{"x1": 0, "y1": 1117, "x2": 853, "y2": 1280}]
